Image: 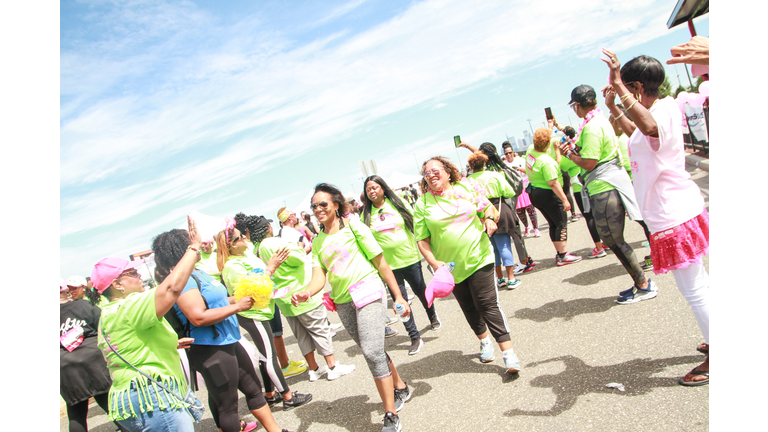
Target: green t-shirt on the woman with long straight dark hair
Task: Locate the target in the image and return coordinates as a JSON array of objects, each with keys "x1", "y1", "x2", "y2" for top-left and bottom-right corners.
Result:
[{"x1": 371, "y1": 198, "x2": 421, "y2": 270}]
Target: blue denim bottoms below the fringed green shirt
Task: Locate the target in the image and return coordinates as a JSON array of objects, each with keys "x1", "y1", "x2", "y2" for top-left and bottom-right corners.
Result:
[{"x1": 117, "y1": 383, "x2": 195, "y2": 432}]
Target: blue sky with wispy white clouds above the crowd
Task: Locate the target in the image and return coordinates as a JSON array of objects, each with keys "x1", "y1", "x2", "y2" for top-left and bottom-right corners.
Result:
[{"x1": 59, "y1": 0, "x2": 709, "y2": 278}]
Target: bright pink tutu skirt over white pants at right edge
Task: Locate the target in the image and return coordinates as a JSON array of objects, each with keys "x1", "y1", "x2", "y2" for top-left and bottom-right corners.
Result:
[{"x1": 651, "y1": 209, "x2": 709, "y2": 274}]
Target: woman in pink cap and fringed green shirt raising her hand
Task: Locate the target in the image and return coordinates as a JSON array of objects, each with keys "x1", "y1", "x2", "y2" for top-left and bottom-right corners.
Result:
[{"x1": 91, "y1": 218, "x2": 201, "y2": 432}]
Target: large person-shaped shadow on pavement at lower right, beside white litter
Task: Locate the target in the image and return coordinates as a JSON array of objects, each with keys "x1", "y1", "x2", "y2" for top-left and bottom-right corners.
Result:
[{"x1": 504, "y1": 355, "x2": 701, "y2": 417}]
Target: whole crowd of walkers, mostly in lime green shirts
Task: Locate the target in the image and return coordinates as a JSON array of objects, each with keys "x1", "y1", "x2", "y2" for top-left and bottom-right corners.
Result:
[{"x1": 60, "y1": 41, "x2": 709, "y2": 432}]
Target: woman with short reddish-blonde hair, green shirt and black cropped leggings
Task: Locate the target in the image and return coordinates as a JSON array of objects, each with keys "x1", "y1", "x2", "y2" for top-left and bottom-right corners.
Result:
[{"x1": 525, "y1": 127, "x2": 581, "y2": 266}]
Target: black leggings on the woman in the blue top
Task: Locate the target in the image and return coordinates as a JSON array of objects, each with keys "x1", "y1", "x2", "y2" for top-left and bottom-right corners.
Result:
[{"x1": 189, "y1": 342, "x2": 267, "y2": 432}]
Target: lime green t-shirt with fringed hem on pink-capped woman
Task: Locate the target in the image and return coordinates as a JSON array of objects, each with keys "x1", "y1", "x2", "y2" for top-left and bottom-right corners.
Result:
[{"x1": 98, "y1": 289, "x2": 187, "y2": 421}]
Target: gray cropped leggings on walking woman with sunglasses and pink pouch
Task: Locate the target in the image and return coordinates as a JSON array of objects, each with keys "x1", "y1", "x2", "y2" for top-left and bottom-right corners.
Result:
[{"x1": 336, "y1": 292, "x2": 392, "y2": 380}]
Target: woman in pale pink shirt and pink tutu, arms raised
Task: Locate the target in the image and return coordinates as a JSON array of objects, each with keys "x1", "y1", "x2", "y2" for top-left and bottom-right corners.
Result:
[{"x1": 602, "y1": 49, "x2": 709, "y2": 386}]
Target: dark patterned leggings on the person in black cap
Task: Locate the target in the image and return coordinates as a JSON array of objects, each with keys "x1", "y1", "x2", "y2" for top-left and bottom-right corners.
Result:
[{"x1": 589, "y1": 189, "x2": 645, "y2": 286}]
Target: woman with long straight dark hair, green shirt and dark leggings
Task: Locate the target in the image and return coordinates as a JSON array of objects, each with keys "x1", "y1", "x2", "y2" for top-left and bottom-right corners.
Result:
[{"x1": 363, "y1": 175, "x2": 432, "y2": 355}]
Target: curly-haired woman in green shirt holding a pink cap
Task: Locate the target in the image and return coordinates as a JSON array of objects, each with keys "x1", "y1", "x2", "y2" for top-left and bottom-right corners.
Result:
[{"x1": 413, "y1": 156, "x2": 520, "y2": 373}]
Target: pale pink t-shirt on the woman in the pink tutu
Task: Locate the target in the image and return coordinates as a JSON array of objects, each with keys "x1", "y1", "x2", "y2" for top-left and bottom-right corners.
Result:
[{"x1": 629, "y1": 96, "x2": 704, "y2": 233}]
